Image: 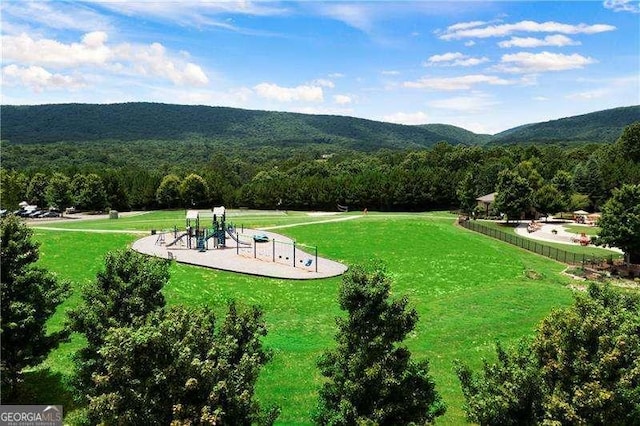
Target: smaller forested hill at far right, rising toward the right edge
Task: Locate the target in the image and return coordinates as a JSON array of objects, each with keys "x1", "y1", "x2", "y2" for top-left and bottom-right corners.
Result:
[{"x1": 489, "y1": 105, "x2": 640, "y2": 145}]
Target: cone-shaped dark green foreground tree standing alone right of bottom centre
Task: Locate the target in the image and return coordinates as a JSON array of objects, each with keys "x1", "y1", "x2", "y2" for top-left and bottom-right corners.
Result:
[{"x1": 314, "y1": 267, "x2": 445, "y2": 425}]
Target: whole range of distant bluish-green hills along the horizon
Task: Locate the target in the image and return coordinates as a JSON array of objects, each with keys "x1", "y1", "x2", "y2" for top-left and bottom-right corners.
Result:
[{"x1": 0, "y1": 102, "x2": 640, "y2": 151}]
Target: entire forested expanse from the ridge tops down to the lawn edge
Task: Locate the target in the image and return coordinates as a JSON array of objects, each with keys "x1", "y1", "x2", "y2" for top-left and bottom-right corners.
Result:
[{"x1": 0, "y1": 100, "x2": 640, "y2": 216}]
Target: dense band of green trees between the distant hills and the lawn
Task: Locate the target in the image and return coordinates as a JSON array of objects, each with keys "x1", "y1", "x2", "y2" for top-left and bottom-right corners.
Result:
[{"x1": 0, "y1": 123, "x2": 640, "y2": 215}]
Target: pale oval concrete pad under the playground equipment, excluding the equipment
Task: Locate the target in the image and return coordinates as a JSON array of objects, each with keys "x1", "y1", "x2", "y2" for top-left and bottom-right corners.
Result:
[{"x1": 132, "y1": 229, "x2": 347, "y2": 280}]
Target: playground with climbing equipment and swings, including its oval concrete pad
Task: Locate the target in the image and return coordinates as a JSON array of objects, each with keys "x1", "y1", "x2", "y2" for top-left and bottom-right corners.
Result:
[{"x1": 142, "y1": 207, "x2": 347, "y2": 279}]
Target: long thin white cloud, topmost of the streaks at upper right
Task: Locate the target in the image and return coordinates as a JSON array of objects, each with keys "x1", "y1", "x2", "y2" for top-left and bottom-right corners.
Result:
[{"x1": 439, "y1": 21, "x2": 616, "y2": 40}]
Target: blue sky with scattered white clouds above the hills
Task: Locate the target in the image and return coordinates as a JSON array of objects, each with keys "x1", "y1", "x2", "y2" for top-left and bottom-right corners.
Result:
[{"x1": 0, "y1": 0, "x2": 640, "y2": 133}]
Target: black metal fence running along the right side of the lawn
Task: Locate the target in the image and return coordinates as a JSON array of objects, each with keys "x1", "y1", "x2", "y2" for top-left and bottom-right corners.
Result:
[{"x1": 460, "y1": 220, "x2": 613, "y2": 265}]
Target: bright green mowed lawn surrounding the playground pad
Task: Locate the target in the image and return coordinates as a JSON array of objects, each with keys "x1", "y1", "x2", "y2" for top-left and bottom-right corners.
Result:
[{"x1": 30, "y1": 212, "x2": 572, "y2": 425}]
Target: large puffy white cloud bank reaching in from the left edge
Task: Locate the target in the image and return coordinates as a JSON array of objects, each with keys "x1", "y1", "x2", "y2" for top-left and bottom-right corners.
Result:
[{"x1": 1, "y1": 31, "x2": 209, "y2": 86}]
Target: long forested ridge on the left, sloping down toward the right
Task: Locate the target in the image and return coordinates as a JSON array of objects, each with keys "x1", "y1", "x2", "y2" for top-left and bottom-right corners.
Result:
[{"x1": 2, "y1": 103, "x2": 483, "y2": 151}]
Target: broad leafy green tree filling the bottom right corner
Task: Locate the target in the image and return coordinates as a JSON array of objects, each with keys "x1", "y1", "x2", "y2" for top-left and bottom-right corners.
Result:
[{"x1": 458, "y1": 284, "x2": 640, "y2": 425}]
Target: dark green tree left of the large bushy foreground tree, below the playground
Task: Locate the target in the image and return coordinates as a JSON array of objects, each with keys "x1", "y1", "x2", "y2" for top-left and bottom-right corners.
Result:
[{"x1": 69, "y1": 250, "x2": 169, "y2": 395}]
